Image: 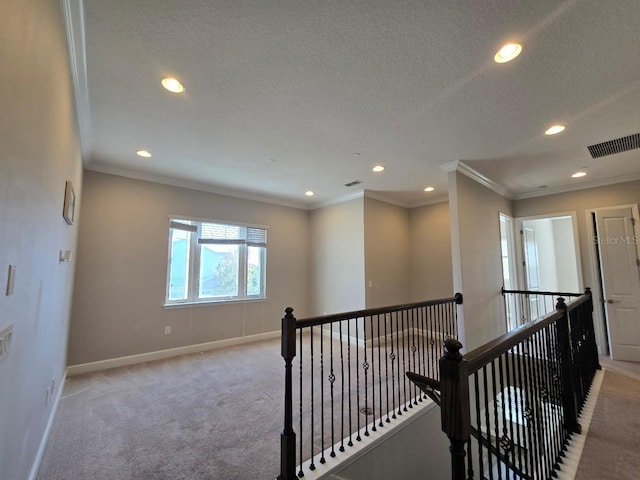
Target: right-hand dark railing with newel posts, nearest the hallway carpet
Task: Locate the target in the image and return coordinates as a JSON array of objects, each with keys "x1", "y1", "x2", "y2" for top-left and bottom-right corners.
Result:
[{"x1": 407, "y1": 291, "x2": 600, "y2": 480}]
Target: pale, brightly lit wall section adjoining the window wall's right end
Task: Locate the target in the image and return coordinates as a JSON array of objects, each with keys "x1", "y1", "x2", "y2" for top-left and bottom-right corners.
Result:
[{"x1": 310, "y1": 198, "x2": 365, "y2": 318}]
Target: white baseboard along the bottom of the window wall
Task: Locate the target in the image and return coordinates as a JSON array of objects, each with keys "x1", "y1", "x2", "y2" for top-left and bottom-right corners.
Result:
[{"x1": 67, "y1": 330, "x2": 281, "y2": 377}]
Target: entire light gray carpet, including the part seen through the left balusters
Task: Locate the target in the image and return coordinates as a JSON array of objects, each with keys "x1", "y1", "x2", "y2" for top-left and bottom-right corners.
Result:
[{"x1": 38, "y1": 334, "x2": 424, "y2": 480}]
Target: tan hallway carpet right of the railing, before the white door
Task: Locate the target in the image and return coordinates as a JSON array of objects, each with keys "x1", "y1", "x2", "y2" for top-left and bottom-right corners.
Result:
[{"x1": 575, "y1": 358, "x2": 640, "y2": 480}]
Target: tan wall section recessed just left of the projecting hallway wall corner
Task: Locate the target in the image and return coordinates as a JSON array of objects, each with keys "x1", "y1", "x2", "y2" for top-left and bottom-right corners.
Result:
[{"x1": 409, "y1": 202, "x2": 455, "y2": 302}]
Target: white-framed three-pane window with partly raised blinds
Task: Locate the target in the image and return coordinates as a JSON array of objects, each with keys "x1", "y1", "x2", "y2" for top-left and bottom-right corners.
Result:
[{"x1": 166, "y1": 218, "x2": 267, "y2": 304}]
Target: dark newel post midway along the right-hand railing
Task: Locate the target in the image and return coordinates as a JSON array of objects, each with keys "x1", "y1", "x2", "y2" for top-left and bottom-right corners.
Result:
[{"x1": 556, "y1": 297, "x2": 582, "y2": 433}]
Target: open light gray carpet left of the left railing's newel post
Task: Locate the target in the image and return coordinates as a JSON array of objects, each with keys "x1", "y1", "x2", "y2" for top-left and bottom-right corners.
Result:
[{"x1": 37, "y1": 339, "x2": 284, "y2": 480}]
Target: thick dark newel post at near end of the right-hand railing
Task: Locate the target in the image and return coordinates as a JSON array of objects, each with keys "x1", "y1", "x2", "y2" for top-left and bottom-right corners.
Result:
[{"x1": 440, "y1": 338, "x2": 471, "y2": 480}]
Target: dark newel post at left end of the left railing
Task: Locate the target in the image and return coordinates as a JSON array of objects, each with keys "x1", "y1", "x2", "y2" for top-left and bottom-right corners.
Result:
[{"x1": 278, "y1": 307, "x2": 297, "y2": 480}]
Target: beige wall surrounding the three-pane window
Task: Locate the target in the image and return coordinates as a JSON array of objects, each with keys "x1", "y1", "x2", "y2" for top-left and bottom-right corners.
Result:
[{"x1": 69, "y1": 171, "x2": 309, "y2": 365}]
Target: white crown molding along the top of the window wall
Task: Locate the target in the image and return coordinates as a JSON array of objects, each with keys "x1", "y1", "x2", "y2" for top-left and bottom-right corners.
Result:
[{"x1": 86, "y1": 162, "x2": 312, "y2": 210}]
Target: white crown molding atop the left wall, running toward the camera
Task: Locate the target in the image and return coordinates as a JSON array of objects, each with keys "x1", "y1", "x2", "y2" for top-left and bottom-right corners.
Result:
[{"x1": 60, "y1": 0, "x2": 92, "y2": 165}]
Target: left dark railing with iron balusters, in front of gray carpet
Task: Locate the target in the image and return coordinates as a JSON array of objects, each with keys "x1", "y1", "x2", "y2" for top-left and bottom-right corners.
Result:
[{"x1": 278, "y1": 294, "x2": 462, "y2": 480}]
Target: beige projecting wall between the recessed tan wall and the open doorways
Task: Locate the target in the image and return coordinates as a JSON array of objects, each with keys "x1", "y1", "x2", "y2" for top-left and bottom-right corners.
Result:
[{"x1": 449, "y1": 172, "x2": 513, "y2": 351}]
